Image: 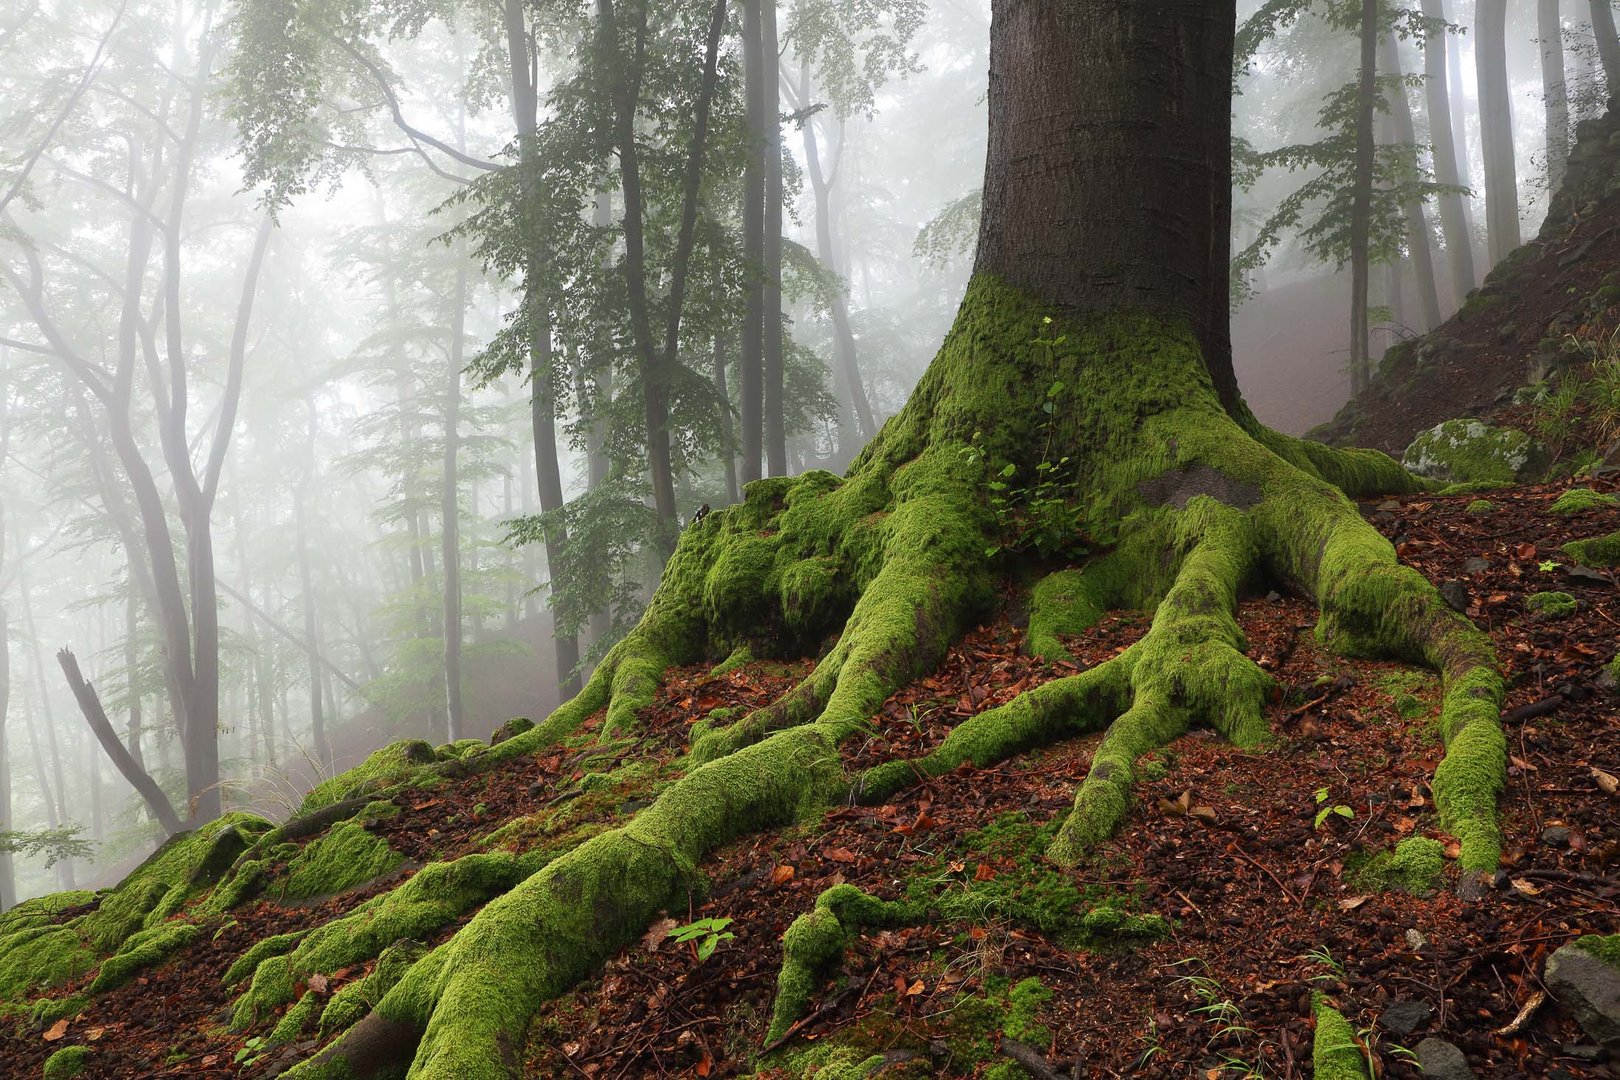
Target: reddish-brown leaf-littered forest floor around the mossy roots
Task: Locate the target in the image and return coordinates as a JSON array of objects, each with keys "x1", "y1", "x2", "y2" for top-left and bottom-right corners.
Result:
[{"x1": 0, "y1": 481, "x2": 1620, "y2": 1080}]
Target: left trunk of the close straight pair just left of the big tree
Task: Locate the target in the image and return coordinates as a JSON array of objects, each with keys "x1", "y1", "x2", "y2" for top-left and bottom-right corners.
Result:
[{"x1": 737, "y1": 0, "x2": 776, "y2": 486}]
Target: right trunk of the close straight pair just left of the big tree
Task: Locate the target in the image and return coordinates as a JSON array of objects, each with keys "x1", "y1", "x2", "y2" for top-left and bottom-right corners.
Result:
[{"x1": 760, "y1": 0, "x2": 787, "y2": 476}]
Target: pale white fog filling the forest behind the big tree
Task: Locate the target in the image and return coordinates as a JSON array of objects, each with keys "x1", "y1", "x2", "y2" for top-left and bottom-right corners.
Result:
[{"x1": 0, "y1": 0, "x2": 1604, "y2": 908}]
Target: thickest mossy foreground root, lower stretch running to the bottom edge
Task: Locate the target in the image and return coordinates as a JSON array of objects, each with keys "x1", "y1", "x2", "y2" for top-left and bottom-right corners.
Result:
[{"x1": 289, "y1": 724, "x2": 839, "y2": 1080}]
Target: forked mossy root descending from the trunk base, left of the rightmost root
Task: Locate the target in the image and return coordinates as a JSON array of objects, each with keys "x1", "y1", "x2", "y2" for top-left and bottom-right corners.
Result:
[{"x1": 1047, "y1": 495, "x2": 1272, "y2": 865}]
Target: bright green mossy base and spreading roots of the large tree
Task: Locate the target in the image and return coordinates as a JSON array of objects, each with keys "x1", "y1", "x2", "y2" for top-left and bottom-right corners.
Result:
[{"x1": 3, "y1": 277, "x2": 1505, "y2": 1080}]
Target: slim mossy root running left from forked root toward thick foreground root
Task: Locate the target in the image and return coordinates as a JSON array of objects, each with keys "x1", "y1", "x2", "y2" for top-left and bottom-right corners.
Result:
[{"x1": 854, "y1": 648, "x2": 1137, "y2": 805}]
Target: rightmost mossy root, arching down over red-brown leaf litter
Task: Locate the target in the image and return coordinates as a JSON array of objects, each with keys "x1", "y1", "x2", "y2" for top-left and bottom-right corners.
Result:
[{"x1": 1257, "y1": 472, "x2": 1507, "y2": 892}]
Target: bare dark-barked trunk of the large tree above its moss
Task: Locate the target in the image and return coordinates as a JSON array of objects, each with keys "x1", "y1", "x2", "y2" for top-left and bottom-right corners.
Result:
[{"x1": 975, "y1": 0, "x2": 1239, "y2": 410}]
